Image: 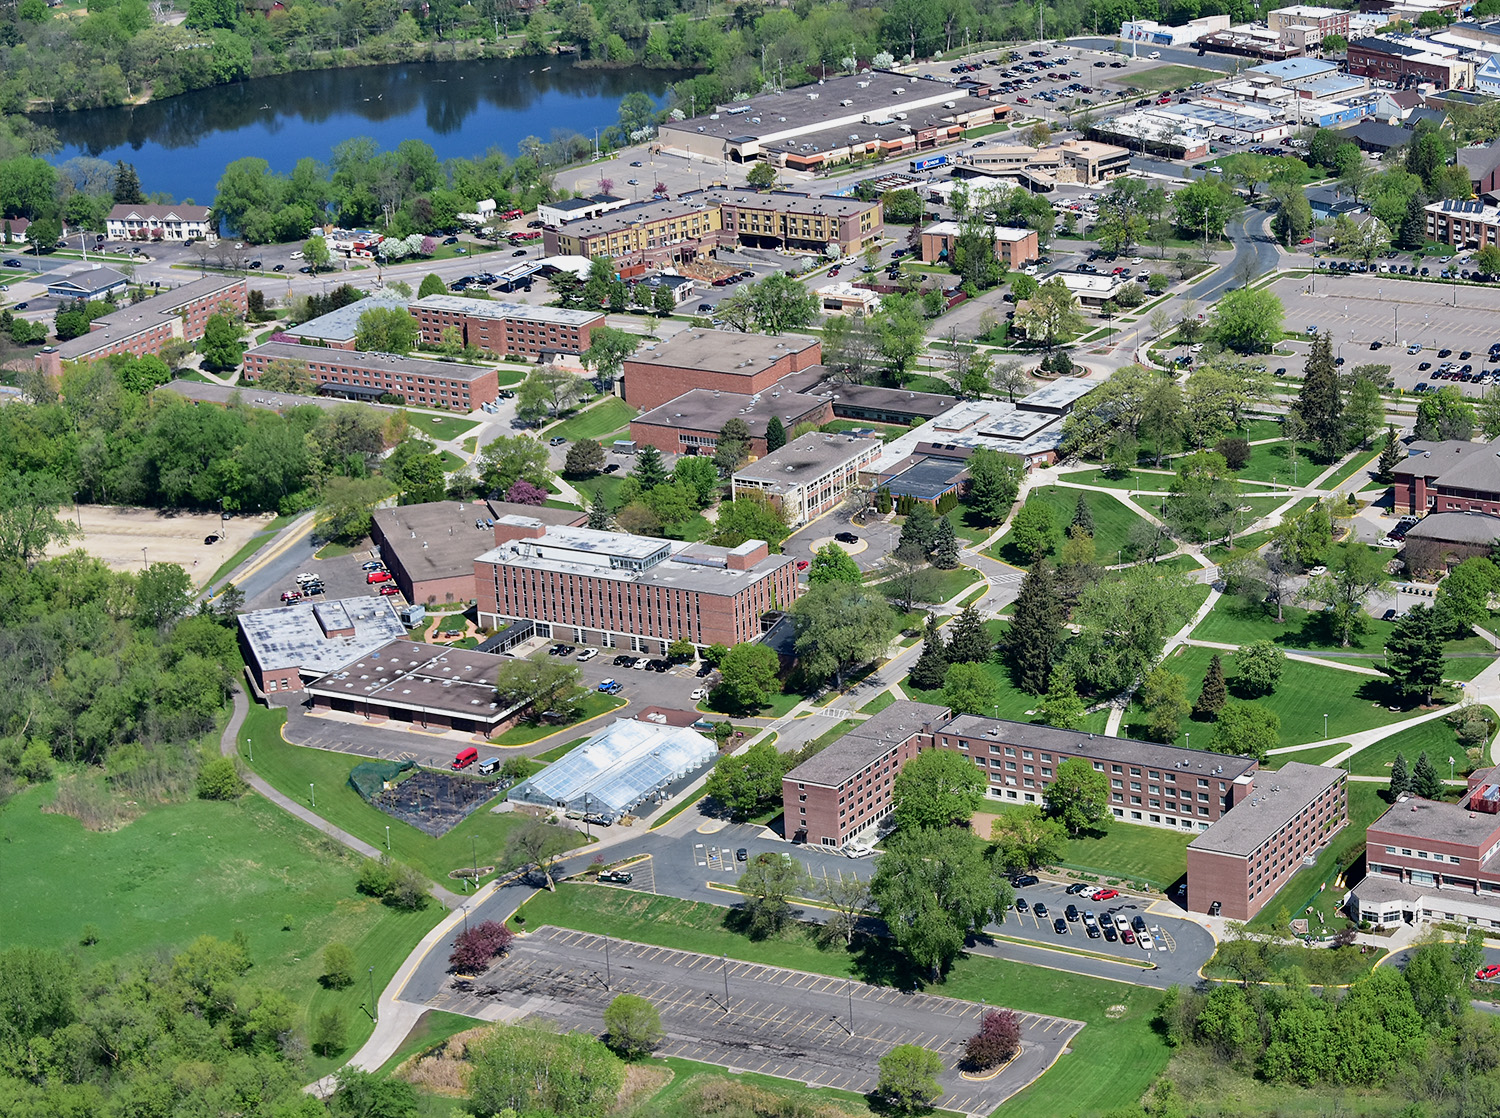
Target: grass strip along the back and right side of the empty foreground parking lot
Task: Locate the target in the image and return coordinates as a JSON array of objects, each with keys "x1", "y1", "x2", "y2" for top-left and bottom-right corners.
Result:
[{"x1": 521, "y1": 884, "x2": 1169, "y2": 1118}]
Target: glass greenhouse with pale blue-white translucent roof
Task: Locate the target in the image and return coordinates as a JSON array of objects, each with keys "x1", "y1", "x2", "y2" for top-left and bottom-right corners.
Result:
[{"x1": 506, "y1": 719, "x2": 719, "y2": 822}]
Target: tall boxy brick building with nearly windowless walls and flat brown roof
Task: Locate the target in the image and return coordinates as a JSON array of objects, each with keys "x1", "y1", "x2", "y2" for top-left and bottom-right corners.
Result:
[{"x1": 621, "y1": 330, "x2": 824, "y2": 408}]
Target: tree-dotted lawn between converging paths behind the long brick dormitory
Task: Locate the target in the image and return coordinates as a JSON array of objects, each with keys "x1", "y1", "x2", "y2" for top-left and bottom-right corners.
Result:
[{"x1": 1125, "y1": 647, "x2": 1418, "y2": 749}]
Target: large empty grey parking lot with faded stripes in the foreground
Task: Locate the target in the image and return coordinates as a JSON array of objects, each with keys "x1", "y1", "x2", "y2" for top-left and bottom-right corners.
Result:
[{"x1": 428, "y1": 927, "x2": 1083, "y2": 1115}]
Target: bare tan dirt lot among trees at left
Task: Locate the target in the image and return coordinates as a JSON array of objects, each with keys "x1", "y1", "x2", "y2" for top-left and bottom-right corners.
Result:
[{"x1": 50, "y1": 504, "x2": 272, "y2": 587}]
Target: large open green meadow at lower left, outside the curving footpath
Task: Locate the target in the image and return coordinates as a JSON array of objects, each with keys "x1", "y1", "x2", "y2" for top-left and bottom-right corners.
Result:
[{"x1": 0, "y1": 785, "x2": 443, "y2": 1074}]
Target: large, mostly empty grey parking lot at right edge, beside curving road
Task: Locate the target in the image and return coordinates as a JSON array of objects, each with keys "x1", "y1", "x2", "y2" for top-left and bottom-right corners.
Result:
[{"x1": 1266, "y1": 273, "x2": 1500, "y2": 396}]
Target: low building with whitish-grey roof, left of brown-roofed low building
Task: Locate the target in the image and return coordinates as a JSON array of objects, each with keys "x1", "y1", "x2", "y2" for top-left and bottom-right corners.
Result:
[{"x1": 240, "y1": 596, "x2": 407, "y2": 693}]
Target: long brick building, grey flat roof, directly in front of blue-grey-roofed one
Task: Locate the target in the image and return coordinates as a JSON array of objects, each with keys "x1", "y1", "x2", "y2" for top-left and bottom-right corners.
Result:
[{"x1": 245, "y1": 342, "x2": 500, "y2": 411}]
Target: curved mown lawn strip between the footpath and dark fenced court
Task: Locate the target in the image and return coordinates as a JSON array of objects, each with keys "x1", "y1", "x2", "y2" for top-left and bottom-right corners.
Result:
[{"x1": 240, "y1": 696, "x2": 582, "y2": 888}]
